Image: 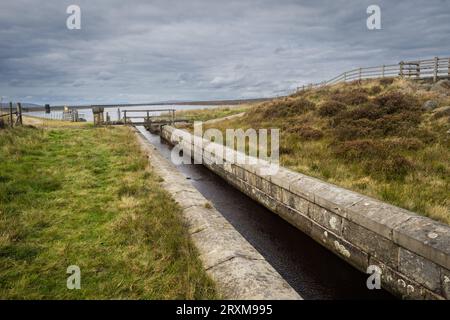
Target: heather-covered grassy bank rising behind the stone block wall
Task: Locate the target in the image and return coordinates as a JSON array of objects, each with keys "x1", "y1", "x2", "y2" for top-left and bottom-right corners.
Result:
[{"x1": 197, "y1": 79, "x2": 450, "y2": 224}]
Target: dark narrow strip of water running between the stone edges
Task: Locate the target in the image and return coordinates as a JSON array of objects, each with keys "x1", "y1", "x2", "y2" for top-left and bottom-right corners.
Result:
[{"x1": 137, "y1": 127, "x2": 394, "y2": 299}]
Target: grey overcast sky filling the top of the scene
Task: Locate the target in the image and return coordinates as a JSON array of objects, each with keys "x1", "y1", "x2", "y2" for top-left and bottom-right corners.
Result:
[{"x1": 0, "y1": 0, "x2": 450, "y2": 104}]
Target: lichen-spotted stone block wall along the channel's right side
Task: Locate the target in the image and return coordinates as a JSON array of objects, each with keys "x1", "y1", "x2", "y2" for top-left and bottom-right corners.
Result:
[{"x1": 161, "y1": 126, "x2": 450, "y2": 299}]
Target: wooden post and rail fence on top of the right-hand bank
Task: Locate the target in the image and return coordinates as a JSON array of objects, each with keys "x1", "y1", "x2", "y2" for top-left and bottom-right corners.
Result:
[{"x1": 296, "y1": 57, "x2": 450, "y2": 92}]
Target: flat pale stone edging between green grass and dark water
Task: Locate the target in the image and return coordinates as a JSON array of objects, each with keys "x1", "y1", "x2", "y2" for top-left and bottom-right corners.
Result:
[{"x1": 135, "y1": 129, "x2": 302, "y2": 300}]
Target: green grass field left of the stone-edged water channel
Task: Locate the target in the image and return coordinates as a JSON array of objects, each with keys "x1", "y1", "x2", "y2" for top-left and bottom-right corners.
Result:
[{"x1": 0, "y1": 126, "x2": 216, "y2": 299}]
